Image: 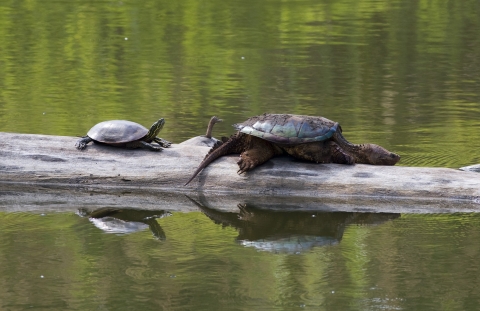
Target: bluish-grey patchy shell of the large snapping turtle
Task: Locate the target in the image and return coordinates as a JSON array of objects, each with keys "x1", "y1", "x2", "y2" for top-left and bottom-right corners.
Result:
[{"x1": 233, "y1": 114, "x2": 341, "y2": 144}]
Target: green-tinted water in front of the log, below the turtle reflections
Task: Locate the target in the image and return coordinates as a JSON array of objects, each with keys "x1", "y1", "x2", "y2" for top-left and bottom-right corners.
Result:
[{"x1": 0, "y1": 213, "x2": 480, "y2": 310}]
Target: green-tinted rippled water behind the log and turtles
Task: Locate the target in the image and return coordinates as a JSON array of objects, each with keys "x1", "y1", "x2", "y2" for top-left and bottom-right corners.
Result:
[{"x1": 0, "y1": 0, "x2": 480, "y2": 166}]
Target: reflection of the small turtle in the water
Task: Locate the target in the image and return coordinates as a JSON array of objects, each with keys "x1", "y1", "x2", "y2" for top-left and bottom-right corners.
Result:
[{"x1": 77, "y1": 207, "x2": 172, "y2": 240}]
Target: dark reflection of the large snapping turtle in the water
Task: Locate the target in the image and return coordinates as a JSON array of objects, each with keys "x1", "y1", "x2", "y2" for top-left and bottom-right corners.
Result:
[{"x1": 192, "y1": 200, "x2": 400, "y2": 254}]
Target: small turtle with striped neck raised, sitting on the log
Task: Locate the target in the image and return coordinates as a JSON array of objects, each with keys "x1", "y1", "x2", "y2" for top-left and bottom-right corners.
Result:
[{"x1": 75, "y1": 118, "x2": 171, "y2": 151}]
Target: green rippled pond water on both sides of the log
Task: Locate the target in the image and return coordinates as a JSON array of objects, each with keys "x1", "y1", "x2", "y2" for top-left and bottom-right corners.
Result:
[{"x1": 0, "y1": 0, "x2": 480, "y2": 310}]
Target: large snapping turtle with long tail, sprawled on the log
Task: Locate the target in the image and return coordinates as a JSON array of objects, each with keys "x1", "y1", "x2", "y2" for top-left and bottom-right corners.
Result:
[{"x1": 185, "y1": 113, "x2": 400, "y2": 185}]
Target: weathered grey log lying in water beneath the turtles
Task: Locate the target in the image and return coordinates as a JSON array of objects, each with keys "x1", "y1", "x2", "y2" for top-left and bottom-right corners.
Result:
[{"x1": 0, "y1": 133, "x2": 480, "y2": 212}]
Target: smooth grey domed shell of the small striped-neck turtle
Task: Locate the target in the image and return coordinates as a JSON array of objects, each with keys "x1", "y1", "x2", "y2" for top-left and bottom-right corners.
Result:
[{"x1": 87, "y1": 120, "x2": 148, "y2": 144}]
